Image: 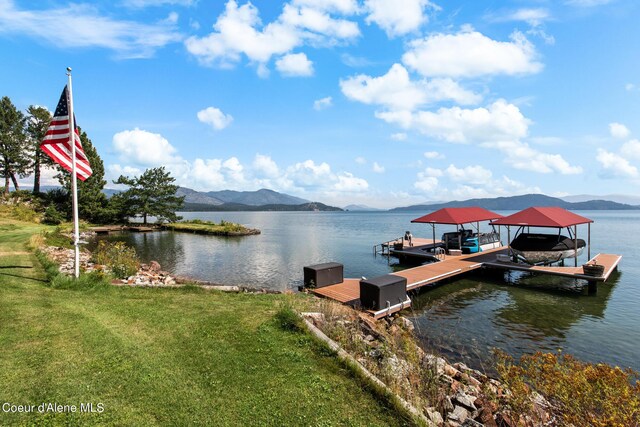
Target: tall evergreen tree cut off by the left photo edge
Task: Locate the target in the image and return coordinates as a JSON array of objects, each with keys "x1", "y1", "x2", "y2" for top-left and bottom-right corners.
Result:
[{"x1": 0, "y1": 96, "x2": 30, "y2": 196}]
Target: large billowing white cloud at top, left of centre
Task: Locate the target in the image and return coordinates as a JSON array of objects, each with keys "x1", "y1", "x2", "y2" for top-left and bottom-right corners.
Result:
[{"x1": 185, "y1": 0, "x2": 360, "y2": 72}]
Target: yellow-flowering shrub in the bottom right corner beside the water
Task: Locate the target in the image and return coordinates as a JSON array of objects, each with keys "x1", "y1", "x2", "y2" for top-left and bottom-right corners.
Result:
[{"x1": 497, "y1": 352, "x2": 640, "y2": 427}]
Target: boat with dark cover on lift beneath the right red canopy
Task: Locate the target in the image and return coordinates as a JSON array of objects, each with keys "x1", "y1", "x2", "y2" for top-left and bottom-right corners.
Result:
[{"x1": 511, "y1": 233, "x2": 586, "y2": 264}]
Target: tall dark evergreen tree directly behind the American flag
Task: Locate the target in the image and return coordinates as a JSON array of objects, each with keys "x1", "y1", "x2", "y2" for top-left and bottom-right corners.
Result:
[{"x1": 56, "y1": 128, "x2": 110, "y2": 223}]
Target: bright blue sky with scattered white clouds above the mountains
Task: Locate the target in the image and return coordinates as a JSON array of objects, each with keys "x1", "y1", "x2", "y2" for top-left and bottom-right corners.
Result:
[{"x1": 0, "y1": 0, "x2": 640, "y2": 207}]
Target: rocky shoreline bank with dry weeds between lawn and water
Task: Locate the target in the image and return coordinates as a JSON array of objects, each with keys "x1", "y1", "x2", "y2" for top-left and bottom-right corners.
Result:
[{"x1": 304, "y1": 309, "x2": 558, "y2": 427}]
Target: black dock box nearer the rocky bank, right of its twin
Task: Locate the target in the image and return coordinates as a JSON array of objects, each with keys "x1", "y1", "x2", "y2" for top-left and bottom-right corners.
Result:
[{"x1": 360, "y1": 274, "x2": 407, "y2": 310}]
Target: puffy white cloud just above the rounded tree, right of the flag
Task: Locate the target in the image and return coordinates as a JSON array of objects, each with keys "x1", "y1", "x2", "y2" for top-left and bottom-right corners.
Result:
[{"x1": 113, "y1": 128, "x2": 182, "y2": 166}]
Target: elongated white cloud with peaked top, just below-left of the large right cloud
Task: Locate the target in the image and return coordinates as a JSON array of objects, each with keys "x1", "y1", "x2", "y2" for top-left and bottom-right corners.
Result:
[{"x1": 340, "y1": 64, "x2": 481, "y2": 111}]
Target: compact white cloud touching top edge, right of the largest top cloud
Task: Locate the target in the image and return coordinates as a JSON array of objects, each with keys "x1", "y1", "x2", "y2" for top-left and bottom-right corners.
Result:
[{"x1": 364, "y1": 0, "x2": 439, "y2": 37}]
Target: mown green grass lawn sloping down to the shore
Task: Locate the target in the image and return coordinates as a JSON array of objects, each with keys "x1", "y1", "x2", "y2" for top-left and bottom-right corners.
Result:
[{"x1": 0, "y1": 218, "x2": 407, "y2": 426}]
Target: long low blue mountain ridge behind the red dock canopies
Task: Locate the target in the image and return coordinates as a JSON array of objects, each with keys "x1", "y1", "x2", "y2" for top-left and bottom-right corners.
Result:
[{"x1": 391, "y1": 194, "x2": 640, "y2": 212}]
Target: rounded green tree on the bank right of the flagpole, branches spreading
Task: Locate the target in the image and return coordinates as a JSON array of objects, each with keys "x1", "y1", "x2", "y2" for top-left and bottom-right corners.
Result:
[{"x1": 114, "y1": 166, "x2": 184, "y2": 224}]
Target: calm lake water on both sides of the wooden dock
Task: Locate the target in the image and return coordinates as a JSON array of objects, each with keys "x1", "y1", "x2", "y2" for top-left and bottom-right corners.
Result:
[{"x1": 92, "y1": 211, "x2": 640, "y2": 370}]
